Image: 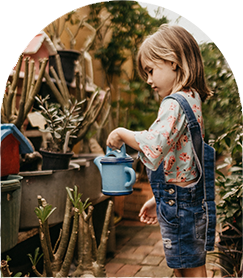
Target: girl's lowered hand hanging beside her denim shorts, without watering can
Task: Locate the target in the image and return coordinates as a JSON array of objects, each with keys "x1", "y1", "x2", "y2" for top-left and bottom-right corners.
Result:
[{"x1": 139, "y1": 197, "x2": 158, "y2": 225}]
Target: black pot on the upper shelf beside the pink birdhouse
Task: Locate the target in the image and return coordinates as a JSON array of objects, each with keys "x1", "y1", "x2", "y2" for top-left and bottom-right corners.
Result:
[{"x1": 49, "y1": 50, "x2": 80, "y2": 83}]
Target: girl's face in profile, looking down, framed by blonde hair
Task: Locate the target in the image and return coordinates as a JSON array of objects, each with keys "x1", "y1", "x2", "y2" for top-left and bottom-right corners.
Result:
[{"x1": 141, "y1": 60, "x2": 176, "y2": 98}]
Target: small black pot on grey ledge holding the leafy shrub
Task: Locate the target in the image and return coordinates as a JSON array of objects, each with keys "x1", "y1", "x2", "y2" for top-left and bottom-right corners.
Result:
[{"x1": 39, "y1": 149, "x2": 74, "y2": 170}]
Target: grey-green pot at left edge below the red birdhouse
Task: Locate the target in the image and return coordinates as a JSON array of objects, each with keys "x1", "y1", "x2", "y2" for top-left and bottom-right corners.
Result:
[{"x1": 0, "y1": 175, "x2": 22, "y2": 253}]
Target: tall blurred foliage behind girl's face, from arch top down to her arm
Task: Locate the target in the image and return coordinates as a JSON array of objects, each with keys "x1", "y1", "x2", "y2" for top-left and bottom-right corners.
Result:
[{"x1": 88, "y1": 0, "x2": 168, "y2": 130}]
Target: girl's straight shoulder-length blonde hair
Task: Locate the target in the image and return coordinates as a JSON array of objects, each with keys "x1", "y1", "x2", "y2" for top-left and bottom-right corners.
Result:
[{"x1": 137, "y1": 24, "x2": 212, "y2": 101}]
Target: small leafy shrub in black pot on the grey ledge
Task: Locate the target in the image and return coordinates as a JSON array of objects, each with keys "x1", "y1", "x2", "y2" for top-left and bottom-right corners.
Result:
[{"x1": 36, "y1": 96, "x2": 83, "y2": 170}]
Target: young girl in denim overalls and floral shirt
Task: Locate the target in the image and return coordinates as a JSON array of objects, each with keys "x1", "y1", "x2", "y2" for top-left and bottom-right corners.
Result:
[{"x1": 107, "y1": 25, "x2": 215, "y2": 278}]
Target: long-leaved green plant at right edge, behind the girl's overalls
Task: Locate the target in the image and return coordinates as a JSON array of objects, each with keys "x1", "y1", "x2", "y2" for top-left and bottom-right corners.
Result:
[{"x1": 214, "y1": 112, "x2": 243, "y2": 230}]
